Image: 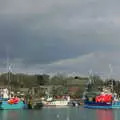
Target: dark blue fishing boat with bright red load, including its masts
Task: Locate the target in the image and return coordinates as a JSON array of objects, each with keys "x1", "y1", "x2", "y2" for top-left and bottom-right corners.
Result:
[{"x1": 83, "y1": 65, "x2": 120, "y2": 109}]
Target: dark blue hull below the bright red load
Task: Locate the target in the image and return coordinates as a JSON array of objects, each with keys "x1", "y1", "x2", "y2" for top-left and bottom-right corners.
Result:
[{"x1": 84, "y1": 101, "x2": 120, "y2": 109}]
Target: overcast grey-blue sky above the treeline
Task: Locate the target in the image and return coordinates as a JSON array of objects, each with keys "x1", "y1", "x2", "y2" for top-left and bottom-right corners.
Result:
[{"x1": 0, "y1": 0, "x2": 120, "y2": 78}]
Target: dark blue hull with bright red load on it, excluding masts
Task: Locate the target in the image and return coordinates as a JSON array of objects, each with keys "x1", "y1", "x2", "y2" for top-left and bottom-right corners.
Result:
[{"x1": 84, "y1": 91, "x2": 120, "y2": 109}]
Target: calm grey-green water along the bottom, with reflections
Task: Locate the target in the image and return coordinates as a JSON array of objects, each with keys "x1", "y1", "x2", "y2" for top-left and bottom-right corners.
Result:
[{"x1": 0, "y1": 107, "x2": 120, "y2": 120}]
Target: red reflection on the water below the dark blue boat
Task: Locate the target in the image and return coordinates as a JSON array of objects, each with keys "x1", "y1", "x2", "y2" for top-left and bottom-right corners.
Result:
[{"x1": 96, "y1": 110, "x2": 114, "y2": 120}]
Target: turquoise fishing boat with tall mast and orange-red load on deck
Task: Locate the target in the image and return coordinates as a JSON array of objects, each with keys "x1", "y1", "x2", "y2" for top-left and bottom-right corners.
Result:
[{"x1": 0, "y1": 64, "x2": 27, "y2": 110}]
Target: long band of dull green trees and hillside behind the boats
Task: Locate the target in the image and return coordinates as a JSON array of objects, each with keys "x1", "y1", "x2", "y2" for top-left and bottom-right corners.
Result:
[{"x1": 0, "y1": 72, "x2": 120, "y2": 97}]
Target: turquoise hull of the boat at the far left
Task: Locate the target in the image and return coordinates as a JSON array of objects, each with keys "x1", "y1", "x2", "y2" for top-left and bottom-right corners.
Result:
[{"x1": 0, "y1": 101, "x2": 26, "y2": 110}]
